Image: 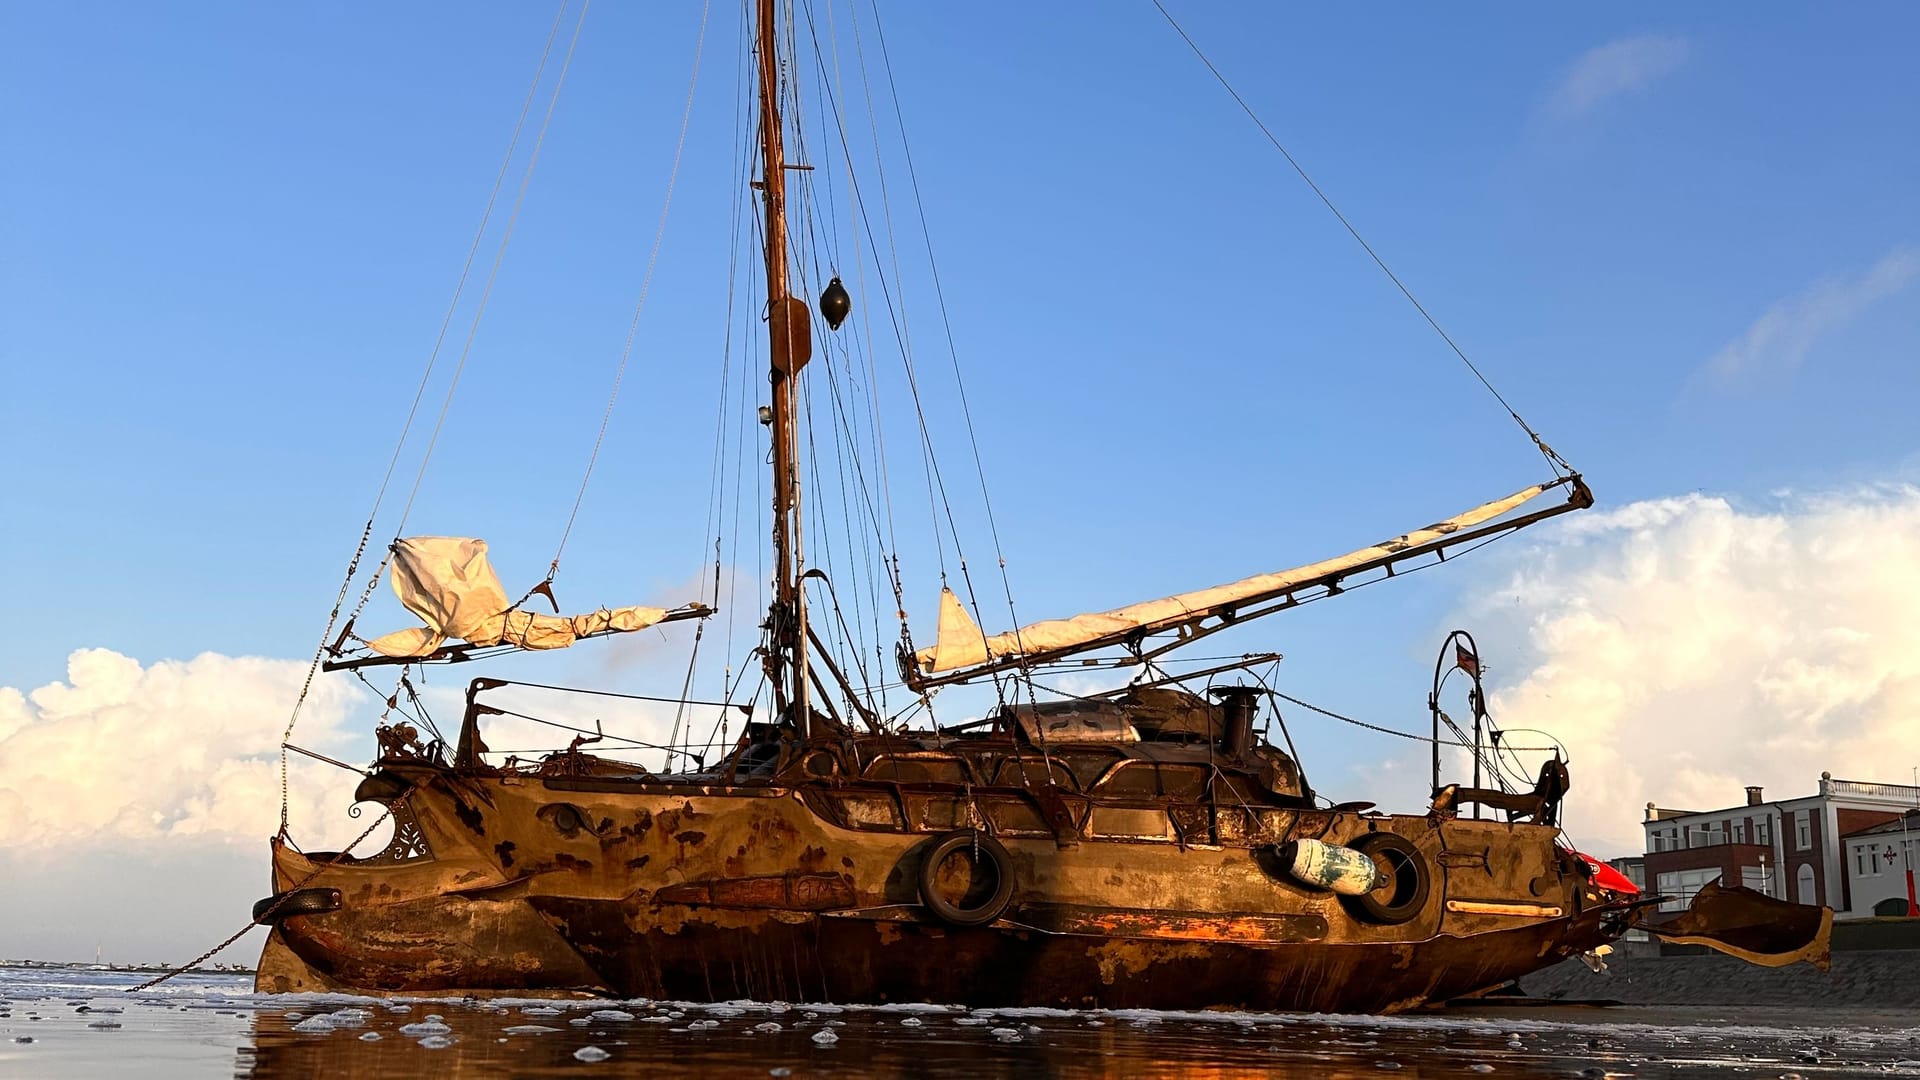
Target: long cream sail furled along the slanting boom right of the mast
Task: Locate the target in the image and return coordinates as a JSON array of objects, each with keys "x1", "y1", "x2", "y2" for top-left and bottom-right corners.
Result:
[{"x1": 914, "y1": 480, "x2": 1561, "y2": 675}]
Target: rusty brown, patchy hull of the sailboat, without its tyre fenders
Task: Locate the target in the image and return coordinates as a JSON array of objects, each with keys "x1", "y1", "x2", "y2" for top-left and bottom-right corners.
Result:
[{"x1": 259, "y1": 757, "x2": 1624, "y2": 1013}]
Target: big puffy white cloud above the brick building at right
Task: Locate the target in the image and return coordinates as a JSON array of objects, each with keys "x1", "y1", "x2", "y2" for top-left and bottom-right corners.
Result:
[{"x1": 1463, "y1": 486, "x2": 1920, "y2": 855}]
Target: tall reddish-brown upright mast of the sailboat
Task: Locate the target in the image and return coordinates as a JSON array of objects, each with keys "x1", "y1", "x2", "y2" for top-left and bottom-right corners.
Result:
[{"x1": 758, "y1": 0, "x2": 812, "y2": 738}]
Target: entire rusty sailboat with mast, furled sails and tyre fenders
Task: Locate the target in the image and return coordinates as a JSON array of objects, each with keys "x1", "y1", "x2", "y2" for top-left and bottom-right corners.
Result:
[{"x1": 253, "y1": 0, "x2": 1832, "y2": 1013}]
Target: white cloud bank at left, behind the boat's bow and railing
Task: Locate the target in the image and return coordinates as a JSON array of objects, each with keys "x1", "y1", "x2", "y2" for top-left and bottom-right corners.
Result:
[{"x1": 0, "y1": 650, "x2": 741, "y2": 963}]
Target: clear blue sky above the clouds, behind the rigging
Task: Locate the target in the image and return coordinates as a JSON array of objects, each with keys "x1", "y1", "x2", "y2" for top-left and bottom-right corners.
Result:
[{"x1": 0, "y1": 2, "x2": 1920, "y2": 926}]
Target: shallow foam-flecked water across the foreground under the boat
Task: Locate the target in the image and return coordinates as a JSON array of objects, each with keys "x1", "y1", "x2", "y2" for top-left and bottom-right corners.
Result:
[{"x1": 0, "y1": 967, "x2": 1920, "y2": 1080}]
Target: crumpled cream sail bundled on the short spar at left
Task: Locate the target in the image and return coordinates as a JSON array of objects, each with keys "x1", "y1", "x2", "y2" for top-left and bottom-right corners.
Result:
[{"x1": 367, "y1": 536, "x2": 666, "y2": 657}]
